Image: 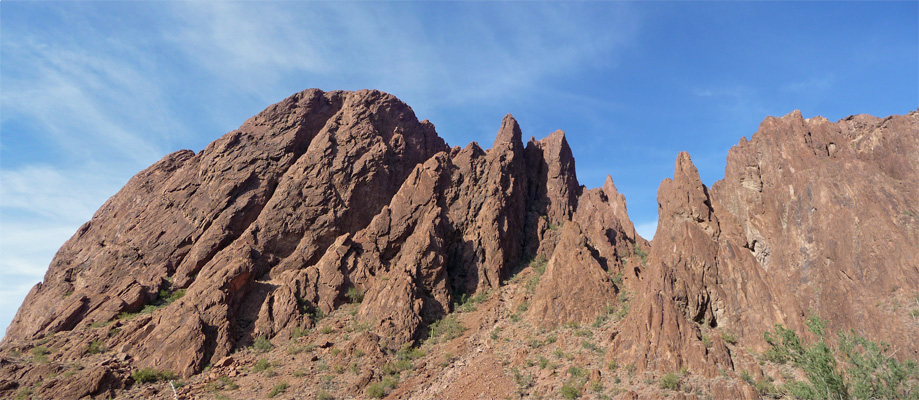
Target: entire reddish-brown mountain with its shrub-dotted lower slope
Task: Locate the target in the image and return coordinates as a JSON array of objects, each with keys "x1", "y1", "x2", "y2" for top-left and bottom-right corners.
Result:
[{"x1": 0, "y1": 90, "x2": 919, "y2": 399}]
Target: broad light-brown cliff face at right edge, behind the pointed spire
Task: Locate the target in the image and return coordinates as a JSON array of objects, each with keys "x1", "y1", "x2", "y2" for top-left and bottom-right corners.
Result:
[{"x1": 712, "y1": 111, "x2": 919, "y2": 359}]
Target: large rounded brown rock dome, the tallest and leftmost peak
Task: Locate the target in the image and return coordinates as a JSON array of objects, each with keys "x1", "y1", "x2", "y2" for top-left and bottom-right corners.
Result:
[{"x1": 7, "y1": 90, "x2": 446, "y2": 373}]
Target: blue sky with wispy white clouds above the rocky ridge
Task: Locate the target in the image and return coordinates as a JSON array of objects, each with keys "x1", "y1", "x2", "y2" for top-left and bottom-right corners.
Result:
[{"x1": 0, "y1": 1, "x2": 919, "y2": 338}]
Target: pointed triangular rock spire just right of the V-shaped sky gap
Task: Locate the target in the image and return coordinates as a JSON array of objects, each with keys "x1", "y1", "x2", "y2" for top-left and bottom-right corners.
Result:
[{"x1": 607, "y1": 153, "x2": 801, "y2": 388}]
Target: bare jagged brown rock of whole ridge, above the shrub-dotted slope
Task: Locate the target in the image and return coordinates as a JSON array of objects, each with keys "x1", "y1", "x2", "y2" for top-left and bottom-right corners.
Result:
[{"x1": 0, "y1": 89, "x2": 919, "y2": 398}]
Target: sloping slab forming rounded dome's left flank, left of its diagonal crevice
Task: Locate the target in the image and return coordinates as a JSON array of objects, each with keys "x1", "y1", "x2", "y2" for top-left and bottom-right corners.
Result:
[{"x1": 6, "y1": 91, "x2": 342, "y2": 341}]
